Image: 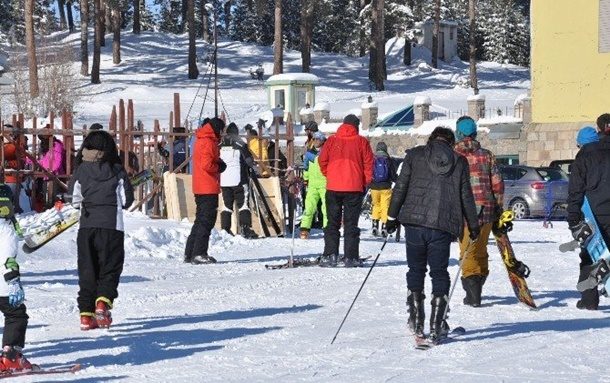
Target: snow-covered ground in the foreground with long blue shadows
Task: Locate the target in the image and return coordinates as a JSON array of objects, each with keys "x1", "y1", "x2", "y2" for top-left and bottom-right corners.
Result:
[{"x1": 14, "y1": 214, "x2": 610, "y2": 382}]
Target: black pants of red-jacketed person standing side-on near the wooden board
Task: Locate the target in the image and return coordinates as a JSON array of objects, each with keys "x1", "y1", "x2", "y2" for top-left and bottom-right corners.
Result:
[{"x1": 184, "y1": 194, "x2": 218, "y2": 259}]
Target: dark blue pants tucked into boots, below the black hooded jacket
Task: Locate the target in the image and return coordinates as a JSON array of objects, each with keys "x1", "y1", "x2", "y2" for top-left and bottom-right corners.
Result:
[{"x1": 405, "y1": 226, "x2": 453, "y2": 296}]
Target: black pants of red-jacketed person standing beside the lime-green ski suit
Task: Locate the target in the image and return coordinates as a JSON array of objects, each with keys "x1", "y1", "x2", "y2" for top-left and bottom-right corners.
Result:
[{"x1": 324, "y1": 190, "x2": 364, "y2": 259}]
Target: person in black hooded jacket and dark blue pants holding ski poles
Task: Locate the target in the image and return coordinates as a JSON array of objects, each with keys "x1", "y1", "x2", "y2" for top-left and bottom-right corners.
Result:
[{"x1": 386, "y1": 127, "x2": 480, "y2": 341}]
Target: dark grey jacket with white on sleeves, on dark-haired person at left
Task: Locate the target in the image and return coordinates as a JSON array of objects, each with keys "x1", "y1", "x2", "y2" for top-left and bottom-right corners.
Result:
[{"x1": 70, "y1": 149, "x2": 134, "y2": 231}]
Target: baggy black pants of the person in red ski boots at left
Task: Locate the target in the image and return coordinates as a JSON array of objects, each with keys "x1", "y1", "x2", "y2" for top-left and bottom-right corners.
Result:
[{"x1": 76, "y1": 228, "x2": 125, "y2": 313}]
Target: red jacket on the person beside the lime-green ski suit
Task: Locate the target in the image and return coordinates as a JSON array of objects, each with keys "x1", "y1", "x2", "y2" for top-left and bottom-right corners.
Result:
[{"x1": 318, "y1": 124, "x2": 375, "y2": 192}]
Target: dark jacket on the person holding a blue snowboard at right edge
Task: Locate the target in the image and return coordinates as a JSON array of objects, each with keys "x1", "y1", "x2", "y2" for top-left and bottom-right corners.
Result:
[{"x1": 568, "y1": 136, "x2": 610, "y2": 226}]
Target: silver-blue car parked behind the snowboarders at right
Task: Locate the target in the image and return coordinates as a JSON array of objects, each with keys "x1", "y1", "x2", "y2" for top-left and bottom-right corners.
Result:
[{"x1": 500, "y1": 165, "x2": 568, "y2": 219}]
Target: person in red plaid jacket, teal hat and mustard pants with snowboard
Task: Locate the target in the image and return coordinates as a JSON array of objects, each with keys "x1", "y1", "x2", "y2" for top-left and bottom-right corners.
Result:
[{"x1": 455, "y1": 116, "x2": 504, "y2": 307}]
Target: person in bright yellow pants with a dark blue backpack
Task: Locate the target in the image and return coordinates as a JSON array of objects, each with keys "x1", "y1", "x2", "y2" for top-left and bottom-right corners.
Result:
[{"x1": 369, "y1": 141, "x2": 397, "y2": 238}]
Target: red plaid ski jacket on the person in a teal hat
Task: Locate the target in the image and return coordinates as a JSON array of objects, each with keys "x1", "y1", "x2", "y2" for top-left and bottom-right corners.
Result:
[{"x1": 454, "y1": 137, "x2": 504, "y2": 225}]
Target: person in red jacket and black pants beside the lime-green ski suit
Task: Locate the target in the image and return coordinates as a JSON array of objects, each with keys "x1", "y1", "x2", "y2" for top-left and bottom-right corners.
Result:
[{"x1": 318, "y1": 114, "x2": 375, "y2": 267}]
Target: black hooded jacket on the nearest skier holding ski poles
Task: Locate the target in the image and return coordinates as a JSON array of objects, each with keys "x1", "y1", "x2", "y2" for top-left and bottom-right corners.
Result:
[{"x1": 388, "y1": 140, "x2": 479, "y2": 237}]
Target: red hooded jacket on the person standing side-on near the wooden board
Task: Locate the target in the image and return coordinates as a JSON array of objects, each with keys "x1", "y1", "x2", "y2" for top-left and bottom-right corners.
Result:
[{"x1": 193, "y1": 124, "x2": 220, "y2": 195}]
